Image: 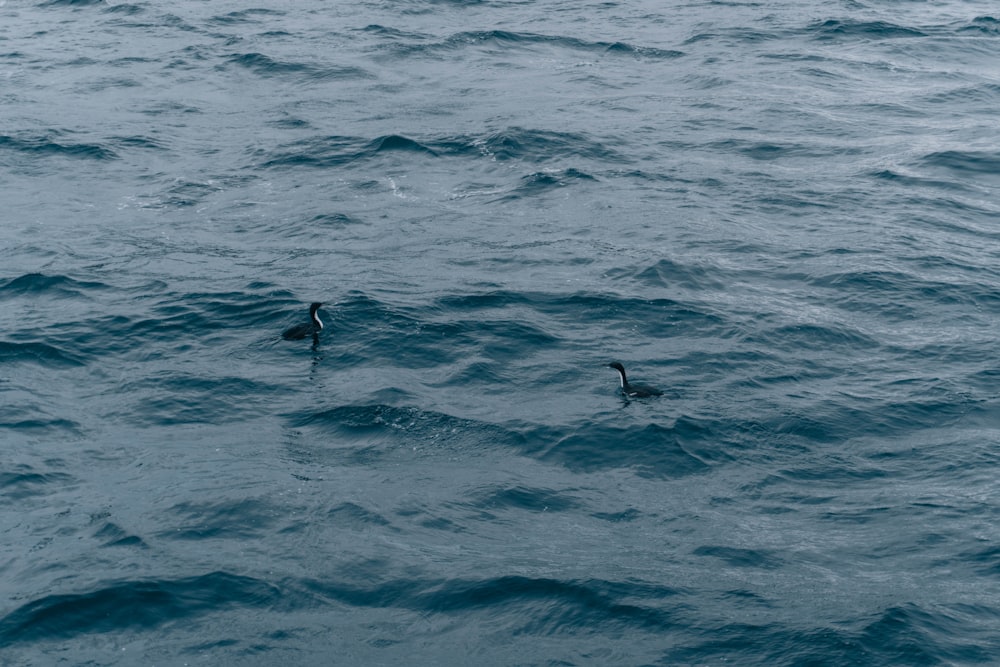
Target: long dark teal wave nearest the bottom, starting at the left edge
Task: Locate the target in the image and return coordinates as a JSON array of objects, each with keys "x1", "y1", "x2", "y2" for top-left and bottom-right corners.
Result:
[{"x1": 0, "y1": 571, "x2": 680, "y2": 646}]
